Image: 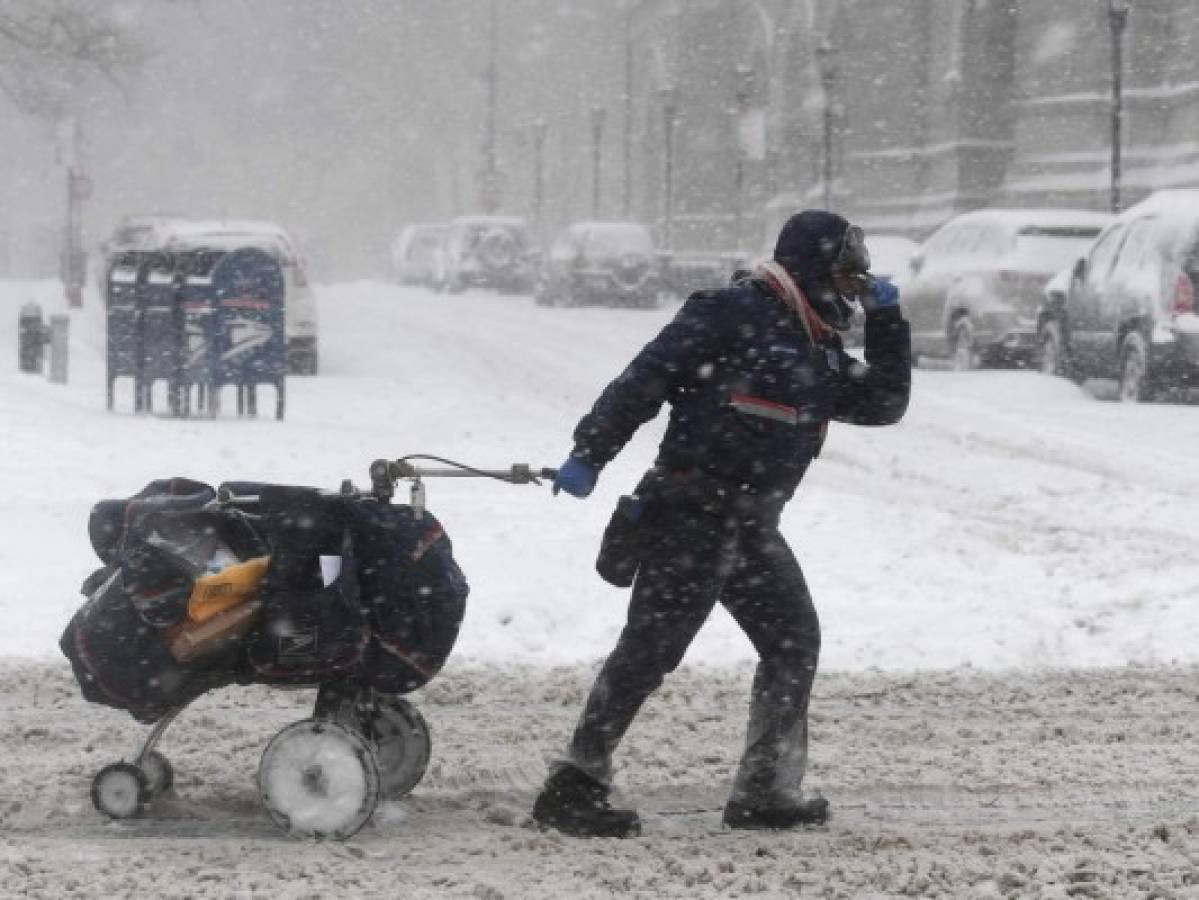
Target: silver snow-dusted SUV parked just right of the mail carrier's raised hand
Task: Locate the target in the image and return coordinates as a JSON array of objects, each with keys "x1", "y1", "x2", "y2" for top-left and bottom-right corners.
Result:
[{"x1": 902, "y1": 210, "x2": 1111, "y2": 369}]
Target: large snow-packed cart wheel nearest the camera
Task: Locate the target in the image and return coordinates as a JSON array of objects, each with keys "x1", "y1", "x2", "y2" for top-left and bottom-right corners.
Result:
[{"x1": 258, "y1": 719, "x2": 379, "y2": 840}]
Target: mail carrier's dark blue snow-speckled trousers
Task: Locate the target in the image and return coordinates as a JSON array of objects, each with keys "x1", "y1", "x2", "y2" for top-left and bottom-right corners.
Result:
[{"x1": 565, "y1": 508, "x2": 820, "y2": 803}]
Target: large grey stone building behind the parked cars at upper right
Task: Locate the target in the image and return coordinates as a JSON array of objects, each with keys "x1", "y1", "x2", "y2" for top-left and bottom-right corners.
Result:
[{"x1": 633, "y1": 0, "x2": 1199, "y2": 252}]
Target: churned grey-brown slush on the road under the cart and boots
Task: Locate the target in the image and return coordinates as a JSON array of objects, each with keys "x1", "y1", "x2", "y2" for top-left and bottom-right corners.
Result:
[{"x1": 0, "y1": 663, "x2": 1199, "y2": 900}]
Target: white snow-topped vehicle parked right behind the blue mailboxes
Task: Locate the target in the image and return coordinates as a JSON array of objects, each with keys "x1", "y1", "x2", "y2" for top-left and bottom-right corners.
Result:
[{"x1": 152, "y1": 219, "x2": 318, "y2": 375}]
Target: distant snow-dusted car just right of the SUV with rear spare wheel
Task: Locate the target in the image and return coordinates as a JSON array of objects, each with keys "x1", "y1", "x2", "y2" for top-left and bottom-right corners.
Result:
[{"x1": 536, "y1": 222, "x2": 659, "y2": 307}]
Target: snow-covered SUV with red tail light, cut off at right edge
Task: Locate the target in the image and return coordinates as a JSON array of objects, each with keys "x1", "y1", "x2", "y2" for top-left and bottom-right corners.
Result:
[{"x1": 1037, "y1": 189, "x2": 1199, "y2": 401}]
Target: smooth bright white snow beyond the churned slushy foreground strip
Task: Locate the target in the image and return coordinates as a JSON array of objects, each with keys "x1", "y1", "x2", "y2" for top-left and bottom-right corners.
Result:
[{"x1": 0, "y1": 283, "x2": 1199, "y2": 670}]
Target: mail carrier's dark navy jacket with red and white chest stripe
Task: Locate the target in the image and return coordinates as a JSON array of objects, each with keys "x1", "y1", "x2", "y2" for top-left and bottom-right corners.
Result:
[{"x1": 573, "y1": 280, "x2": 911, "y2": 499}]
